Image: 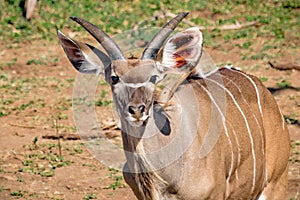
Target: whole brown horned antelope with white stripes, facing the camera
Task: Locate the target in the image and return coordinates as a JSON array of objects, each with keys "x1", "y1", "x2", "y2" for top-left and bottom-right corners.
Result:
[{"x1": 58, "y1": 13, "x2": 289, "y2": 200}]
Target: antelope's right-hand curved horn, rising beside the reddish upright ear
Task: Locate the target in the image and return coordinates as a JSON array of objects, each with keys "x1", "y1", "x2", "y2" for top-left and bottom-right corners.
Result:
[{"x1": 141, "y1": 12, "x2": 189, "y2": 60}]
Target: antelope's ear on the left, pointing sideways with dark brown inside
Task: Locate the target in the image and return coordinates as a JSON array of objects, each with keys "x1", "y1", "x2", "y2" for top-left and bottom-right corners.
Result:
[{"x1": 57, "y1": 31, "x2": 111, "y2": 74}]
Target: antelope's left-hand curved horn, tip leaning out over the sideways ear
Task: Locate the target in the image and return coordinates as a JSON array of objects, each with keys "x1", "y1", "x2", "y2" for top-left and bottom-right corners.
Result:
[{"x1": 70, "y1": 17, "x2": 125, "y2": 60}]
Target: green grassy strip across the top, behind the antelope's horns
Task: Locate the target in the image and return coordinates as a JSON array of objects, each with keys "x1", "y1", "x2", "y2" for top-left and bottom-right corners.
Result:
[{"x1": 0, "y1": 0, "x2": 300, "y2": 49}]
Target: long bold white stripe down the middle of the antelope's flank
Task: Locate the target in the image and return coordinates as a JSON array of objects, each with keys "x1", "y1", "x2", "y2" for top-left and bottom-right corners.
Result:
[{"x1": 205, "y1": 78, "x2": 256, "y2": 194}]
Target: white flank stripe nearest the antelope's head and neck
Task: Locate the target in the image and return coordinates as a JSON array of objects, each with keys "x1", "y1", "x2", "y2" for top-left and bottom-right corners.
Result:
[{"x1": 197, "y1": 82, "x2": 234, "y2": 195}]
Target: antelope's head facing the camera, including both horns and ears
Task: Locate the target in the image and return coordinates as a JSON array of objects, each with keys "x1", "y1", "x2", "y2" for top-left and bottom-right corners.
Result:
[{"x1": 58, "y1": 13, "x2": 202, "y2": 127}]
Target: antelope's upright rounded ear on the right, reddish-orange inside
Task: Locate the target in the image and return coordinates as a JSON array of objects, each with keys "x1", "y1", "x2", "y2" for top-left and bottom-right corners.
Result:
[{"x1": 161, "y1": 27, "x2": 203, "y2": 72}]
